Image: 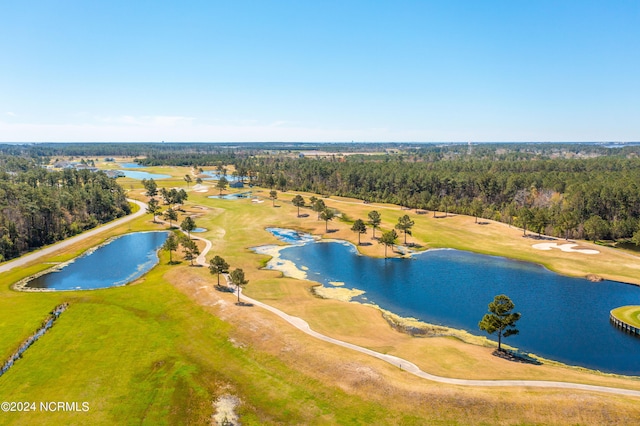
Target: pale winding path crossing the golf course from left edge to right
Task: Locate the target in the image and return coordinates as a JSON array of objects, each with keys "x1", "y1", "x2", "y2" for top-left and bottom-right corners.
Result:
[{"x1": 0, "y1": 199, "x2": 640, "y2": 397}]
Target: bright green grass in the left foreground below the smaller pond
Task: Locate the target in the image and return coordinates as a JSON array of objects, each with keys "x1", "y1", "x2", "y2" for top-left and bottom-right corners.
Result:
[{"x1": 0, "y1": 215, "x2": 415, "y2": 425}]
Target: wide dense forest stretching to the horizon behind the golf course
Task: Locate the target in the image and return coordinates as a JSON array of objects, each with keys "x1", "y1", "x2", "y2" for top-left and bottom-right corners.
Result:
[{"x1": 0, "y1": 143, "x2": 640, "y2": 248}]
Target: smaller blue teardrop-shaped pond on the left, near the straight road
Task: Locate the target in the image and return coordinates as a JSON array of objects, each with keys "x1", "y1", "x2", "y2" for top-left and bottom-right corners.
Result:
[{"x1": 25, "y1": 231, "x2": 169, "y2": 290}]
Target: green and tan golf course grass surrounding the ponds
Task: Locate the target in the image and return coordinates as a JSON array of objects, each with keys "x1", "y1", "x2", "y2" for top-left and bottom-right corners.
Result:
[{"x1": 0, "y1": 164, "x2": 640, "y2": 425}]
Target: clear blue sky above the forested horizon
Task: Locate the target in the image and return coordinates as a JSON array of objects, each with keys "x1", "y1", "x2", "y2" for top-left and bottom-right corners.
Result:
[{"x1": 0, "y1": 0, "x2": 640, "y2": 142}]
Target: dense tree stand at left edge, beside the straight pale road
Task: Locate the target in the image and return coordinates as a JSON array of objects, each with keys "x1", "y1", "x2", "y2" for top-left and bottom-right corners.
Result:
[{"x1": 0, "y1": 155, "x2": 131, "y2": 261}]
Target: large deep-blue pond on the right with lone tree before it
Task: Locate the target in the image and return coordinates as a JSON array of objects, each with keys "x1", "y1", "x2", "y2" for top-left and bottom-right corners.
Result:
[{"x1": 262, "y1": 229, "x2": 640, "y2": 375}]
